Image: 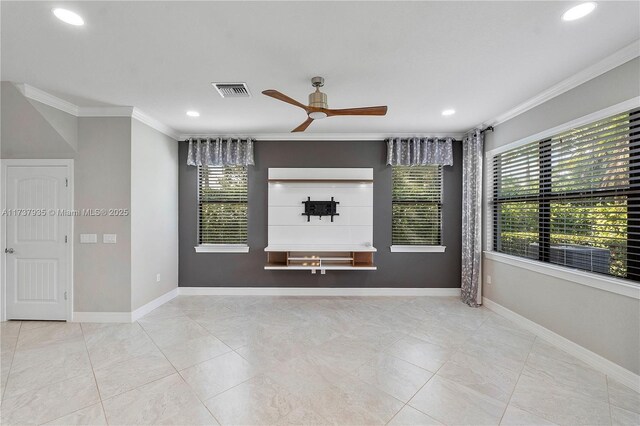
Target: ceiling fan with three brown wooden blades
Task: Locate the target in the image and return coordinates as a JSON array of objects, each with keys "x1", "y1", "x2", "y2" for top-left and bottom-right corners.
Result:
[{"x1": 262, "y1": 77, "x2": 387, "y2": 132}]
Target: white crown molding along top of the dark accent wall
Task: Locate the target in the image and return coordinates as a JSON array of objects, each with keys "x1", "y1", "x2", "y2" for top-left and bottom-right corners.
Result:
[{"x1": 178, "y1": 133, "x2": 464, "y2": 142}]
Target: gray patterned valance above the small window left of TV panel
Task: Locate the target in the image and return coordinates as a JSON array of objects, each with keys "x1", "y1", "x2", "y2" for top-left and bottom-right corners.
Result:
[{"x1": 187, "y1": 138, "x2": 254, "y2": 166}]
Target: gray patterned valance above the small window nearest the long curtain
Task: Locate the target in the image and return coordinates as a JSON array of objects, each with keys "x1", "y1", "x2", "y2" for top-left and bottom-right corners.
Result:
[{"x1": 387, "y1": 138, "x2": 453, "y2": 166}]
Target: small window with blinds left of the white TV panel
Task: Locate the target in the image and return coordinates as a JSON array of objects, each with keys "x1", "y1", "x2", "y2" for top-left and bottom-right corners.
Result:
[{"x1": 198, "y1": 166, "x2": 247, "y2": 245}]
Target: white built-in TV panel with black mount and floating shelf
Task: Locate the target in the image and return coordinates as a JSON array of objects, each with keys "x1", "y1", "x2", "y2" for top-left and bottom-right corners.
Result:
[{"x1": 265, "y1": 168, "x2": 376, "y2": 273}]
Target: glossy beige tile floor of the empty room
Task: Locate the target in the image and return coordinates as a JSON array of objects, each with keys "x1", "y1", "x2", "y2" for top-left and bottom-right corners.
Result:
[{"x1": 0, "y1": 296, "x2": 640, "y2": 425}]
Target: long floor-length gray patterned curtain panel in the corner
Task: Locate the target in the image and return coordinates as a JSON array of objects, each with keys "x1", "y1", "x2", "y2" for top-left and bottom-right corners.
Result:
[{"x1": 460, "y1": 129, "x2": 484, "y2": 307}]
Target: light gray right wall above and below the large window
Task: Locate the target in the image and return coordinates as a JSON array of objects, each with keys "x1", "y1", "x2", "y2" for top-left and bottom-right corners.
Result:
[{"x1": 483, "y1": 59, "x2": 640, "y2": 374}]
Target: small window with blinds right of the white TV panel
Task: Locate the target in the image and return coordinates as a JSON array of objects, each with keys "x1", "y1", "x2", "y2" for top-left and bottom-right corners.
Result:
[{"x1": 392, "y1": 166, "x2": 442, "y2": 246}]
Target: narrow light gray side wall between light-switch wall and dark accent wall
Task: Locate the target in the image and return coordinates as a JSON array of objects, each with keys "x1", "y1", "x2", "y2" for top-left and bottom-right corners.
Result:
[{"x1": 131, "y1": 120, "x2": 178, "y2": 310}]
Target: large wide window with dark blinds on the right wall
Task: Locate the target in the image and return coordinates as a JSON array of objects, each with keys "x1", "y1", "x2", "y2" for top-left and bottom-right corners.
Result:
[{"x1": 491, "y1": 109, "x2": 640, "y2": 281}]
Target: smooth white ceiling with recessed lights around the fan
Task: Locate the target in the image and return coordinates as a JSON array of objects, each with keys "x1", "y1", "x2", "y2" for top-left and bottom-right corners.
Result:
[{"x1": 0, "y1": 1, "x2": 640, "y2": 134}]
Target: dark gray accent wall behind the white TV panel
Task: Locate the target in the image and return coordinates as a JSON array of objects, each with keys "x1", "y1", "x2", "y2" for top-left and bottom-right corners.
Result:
[{"x1": 179, "y1": 141, "x2": 462, "y2": 288}]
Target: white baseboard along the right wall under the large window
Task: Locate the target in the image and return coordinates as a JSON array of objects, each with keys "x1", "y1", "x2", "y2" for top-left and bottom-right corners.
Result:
[{"x1": 482, "y1": 297, "x2": 640, "y2": 392}]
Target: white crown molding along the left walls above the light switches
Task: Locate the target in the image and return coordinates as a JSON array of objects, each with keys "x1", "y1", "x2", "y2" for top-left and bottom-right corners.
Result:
[{"x1": 14, "y1": 83, "x2": 179, "y2": 140}]
